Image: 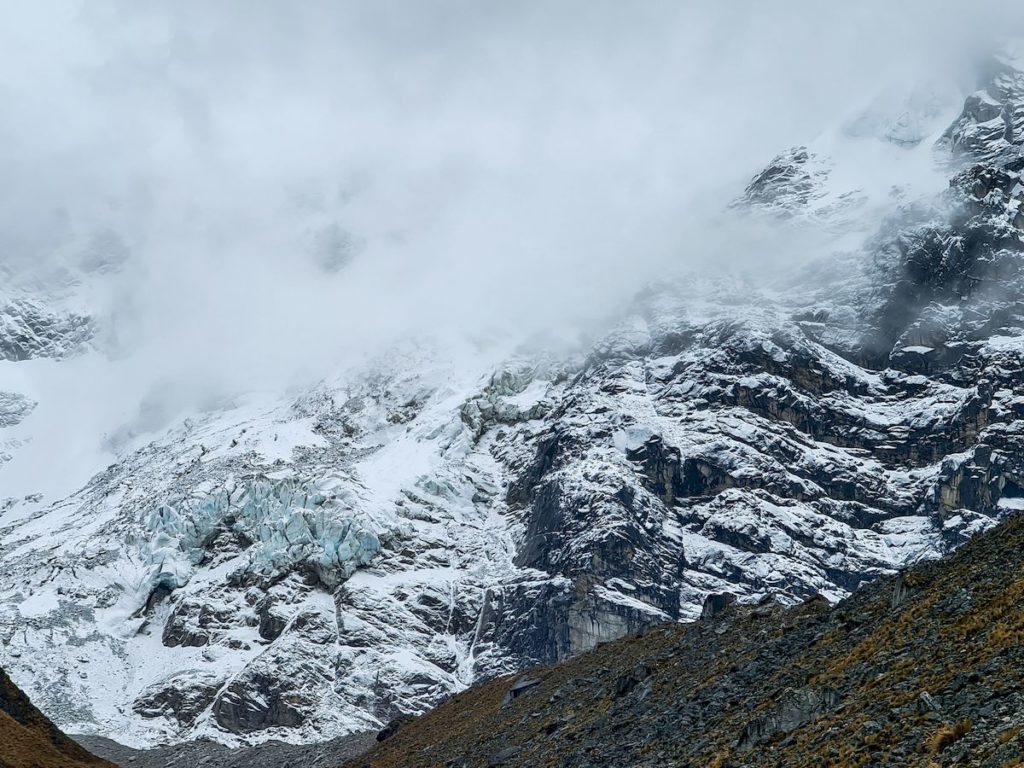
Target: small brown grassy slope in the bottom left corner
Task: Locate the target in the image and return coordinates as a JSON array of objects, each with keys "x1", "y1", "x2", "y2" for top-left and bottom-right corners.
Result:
[{"x1": 0, "y1": 670, "x2": 113, "y2": 768}]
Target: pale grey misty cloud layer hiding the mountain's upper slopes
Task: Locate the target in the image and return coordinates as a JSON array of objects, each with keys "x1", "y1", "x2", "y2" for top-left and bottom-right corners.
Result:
[{"x1": 6, "y1": 0, "x2": 1024, "y2": 481}]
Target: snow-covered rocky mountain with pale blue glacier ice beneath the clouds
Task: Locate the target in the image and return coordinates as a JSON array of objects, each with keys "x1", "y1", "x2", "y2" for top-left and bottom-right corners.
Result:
[{"x1": 0, "y1": 48, "x2": 1024, "y2": 743}]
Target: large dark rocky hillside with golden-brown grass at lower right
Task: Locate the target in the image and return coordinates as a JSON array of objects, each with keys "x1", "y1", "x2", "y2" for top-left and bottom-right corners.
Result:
[{"x1": 347, "y1": 517, "x2": 1024, "y2": 768}]
